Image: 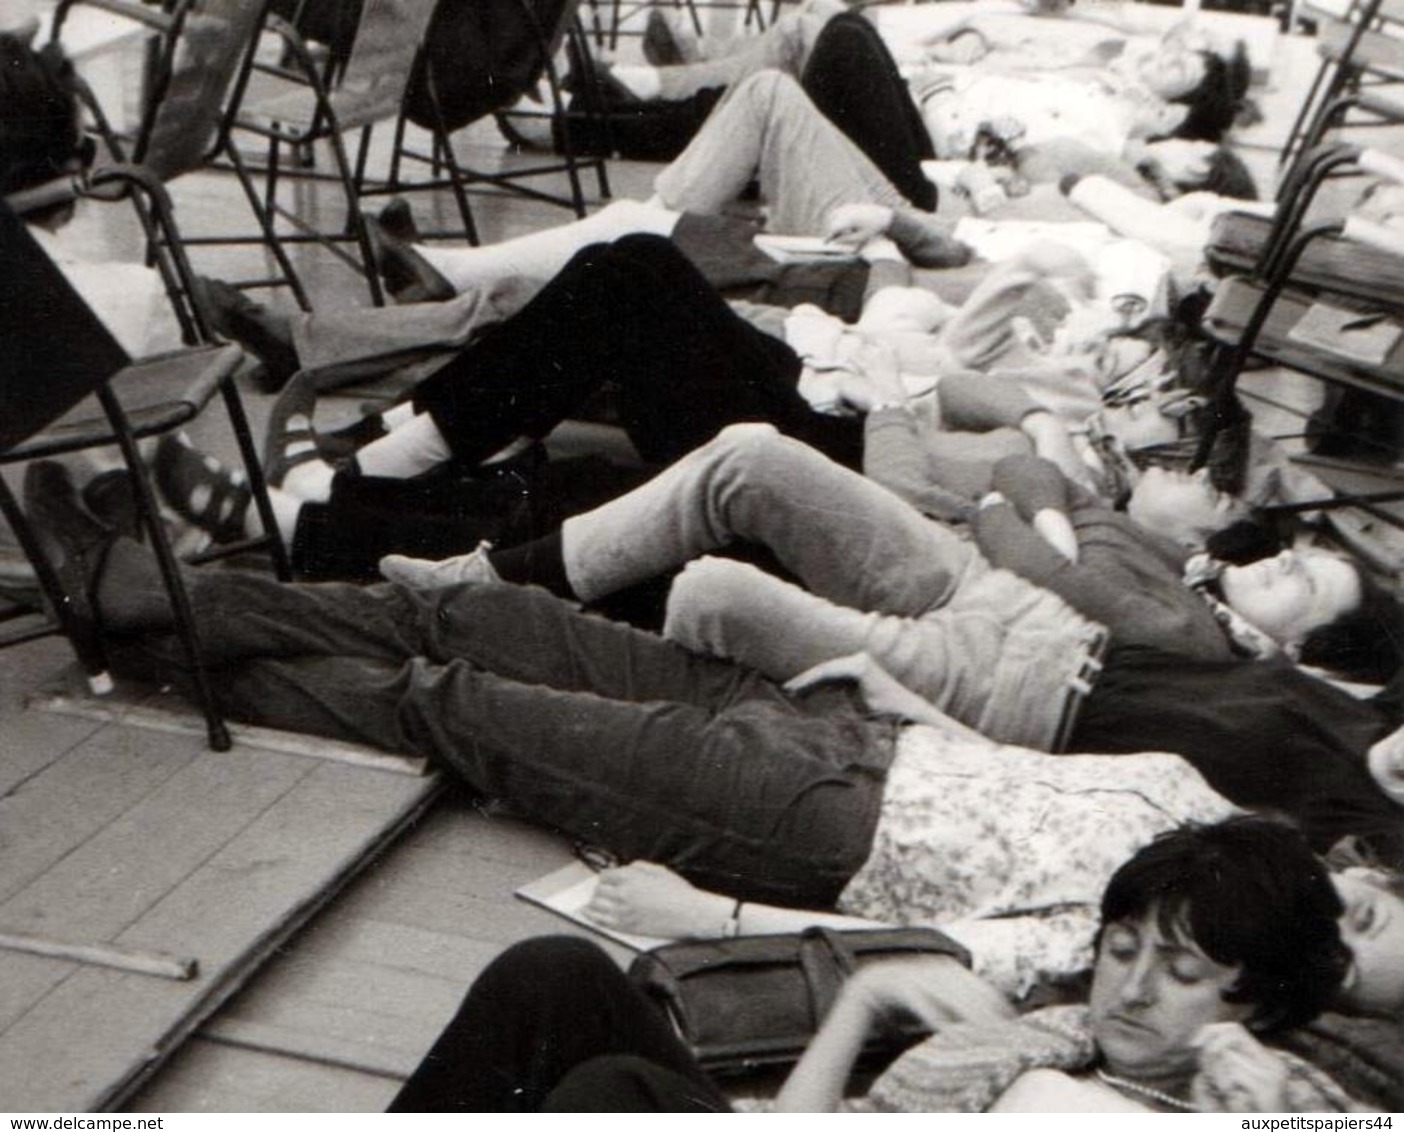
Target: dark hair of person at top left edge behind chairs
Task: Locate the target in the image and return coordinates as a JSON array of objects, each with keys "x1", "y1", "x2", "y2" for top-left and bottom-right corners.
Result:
[{"x1": 0, "y1": 35, "x2": 83, "y2": 195}]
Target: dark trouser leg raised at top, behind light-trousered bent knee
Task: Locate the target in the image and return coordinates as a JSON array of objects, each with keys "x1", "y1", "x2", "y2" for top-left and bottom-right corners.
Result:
[{"x1": 800, "y1": 11, "x2": 936, "y2": 212}]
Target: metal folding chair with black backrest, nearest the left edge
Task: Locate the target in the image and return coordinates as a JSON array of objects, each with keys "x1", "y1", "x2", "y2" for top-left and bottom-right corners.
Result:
[{"x1": 0, "y1": 167, "x2": 291, "y2": 750}]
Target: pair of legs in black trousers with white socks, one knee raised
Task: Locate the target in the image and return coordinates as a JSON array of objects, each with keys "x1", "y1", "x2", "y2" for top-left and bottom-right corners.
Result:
[{"x1": 187, "y1": 235, "x2": 862, "y2": 579}]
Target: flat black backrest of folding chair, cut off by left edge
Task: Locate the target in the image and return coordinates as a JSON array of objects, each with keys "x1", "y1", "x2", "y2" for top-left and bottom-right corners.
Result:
[{"x1": 0, "y1": 201, "x2": 131, "y2": 452}]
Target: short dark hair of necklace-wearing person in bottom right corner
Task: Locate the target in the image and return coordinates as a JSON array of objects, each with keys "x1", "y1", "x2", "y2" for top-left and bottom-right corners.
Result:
[{"x1": 1098, "y1": 816, "x2": 1351, "y2": 1034}]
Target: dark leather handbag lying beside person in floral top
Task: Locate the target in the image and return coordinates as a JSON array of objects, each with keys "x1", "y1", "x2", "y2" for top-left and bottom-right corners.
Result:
[{"x1": 629, "y1": 927, "x2": 970, "y2": 1073}]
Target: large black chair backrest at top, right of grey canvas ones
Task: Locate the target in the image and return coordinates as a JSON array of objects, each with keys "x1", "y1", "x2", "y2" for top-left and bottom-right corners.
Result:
[{"x1": 404, "y1": 0, "x2": 580, "y2": 131}]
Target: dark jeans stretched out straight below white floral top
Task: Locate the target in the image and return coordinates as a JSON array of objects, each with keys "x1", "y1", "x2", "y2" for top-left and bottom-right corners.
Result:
[{"x1": 117, "y1": 572, "x2": 893, "y2": 906}]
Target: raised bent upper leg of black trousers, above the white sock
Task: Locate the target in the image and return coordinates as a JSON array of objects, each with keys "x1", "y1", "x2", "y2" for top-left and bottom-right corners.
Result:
[{"x1": 414, "y1": 236, "x2": 862, "y2": 466}]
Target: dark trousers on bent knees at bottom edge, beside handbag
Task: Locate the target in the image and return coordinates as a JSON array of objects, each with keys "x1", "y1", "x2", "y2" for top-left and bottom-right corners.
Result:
[{"x1": 389, "y1": 935, "x2": 730, "y2": 1112}]
